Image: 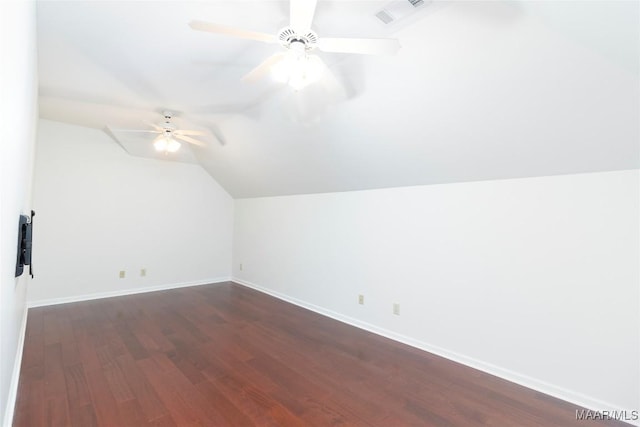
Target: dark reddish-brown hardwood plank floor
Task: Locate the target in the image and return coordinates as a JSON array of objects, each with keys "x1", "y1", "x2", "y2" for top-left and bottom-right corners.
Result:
[{"x1": 14, "y1": 283, "x2": 623, "y2": 427}]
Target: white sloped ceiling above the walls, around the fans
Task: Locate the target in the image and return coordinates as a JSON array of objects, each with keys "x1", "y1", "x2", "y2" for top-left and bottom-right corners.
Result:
[{"x1": 38, "y1": 0, "x2": 640, "y2": 197}]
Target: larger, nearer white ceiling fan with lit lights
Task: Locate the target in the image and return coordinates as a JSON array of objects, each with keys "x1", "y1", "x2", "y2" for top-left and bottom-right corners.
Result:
[{"x1": 189, "y1": 0, "x2": 400, "y2": 89}]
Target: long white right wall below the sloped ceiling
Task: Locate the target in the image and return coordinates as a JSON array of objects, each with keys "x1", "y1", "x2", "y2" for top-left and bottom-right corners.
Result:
[{"x1": 233, "y1": 170, "x2": 640, "y2": 410}]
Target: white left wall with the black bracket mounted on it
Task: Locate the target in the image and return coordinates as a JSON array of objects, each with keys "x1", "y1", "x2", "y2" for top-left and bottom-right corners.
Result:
[{"x1": 0, "y1": 1, "x2": 37, "y2": 425}]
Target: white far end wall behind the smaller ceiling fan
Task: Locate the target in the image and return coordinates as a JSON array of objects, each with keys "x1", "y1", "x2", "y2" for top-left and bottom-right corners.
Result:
[{"x1": 28, "y1": 120, "x2": 233, "y2": 305}]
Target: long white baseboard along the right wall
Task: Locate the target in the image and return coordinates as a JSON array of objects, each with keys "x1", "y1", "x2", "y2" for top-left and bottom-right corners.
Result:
[{"x1": 231, "y1": 277, "x2": 640, "y2": 426}]
